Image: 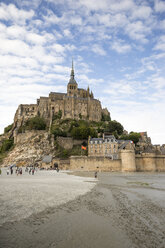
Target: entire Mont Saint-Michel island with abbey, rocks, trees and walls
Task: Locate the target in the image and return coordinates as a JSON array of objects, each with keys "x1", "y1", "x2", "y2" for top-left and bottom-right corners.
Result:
[{"x1": 0, "y1": 61, "x2": 165, "y2": 171}]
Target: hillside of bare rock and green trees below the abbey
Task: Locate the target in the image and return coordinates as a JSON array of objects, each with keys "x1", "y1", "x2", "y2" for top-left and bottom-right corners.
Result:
[{"x1": 0, "y1": 115, "x2": 123, "y2": 164}]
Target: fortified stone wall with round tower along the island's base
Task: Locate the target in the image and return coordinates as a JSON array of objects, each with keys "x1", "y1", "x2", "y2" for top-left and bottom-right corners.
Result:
[{"x1": 69, "y1": 150, "x2": 165, "y2": 172}]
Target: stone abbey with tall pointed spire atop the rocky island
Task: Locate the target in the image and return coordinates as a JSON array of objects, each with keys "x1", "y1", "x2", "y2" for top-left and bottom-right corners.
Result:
[{"x1": 14, "y1": 61, "x2": 109, "y2": 128}]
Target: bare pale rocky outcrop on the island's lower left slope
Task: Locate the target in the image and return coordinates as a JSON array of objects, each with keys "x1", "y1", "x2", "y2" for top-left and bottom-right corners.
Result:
[{"x1": 3, "y1": 130, "x2": 55, "y2": 166}]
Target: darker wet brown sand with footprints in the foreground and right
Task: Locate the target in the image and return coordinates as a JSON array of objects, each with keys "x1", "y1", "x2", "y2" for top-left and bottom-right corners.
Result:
[{"x1": 0, "y1": 172, "x2": 165, "y2": 248}]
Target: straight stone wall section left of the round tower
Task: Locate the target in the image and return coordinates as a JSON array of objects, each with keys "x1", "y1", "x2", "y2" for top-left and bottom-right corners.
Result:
[{"x1": 70, "y1": 156, "x2": 121, "y2": 171}]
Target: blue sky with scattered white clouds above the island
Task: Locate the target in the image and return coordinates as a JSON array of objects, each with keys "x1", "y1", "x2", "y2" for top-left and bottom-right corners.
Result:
[{"x1": 0, "y1": 0, "x2": 165, "y2": 144}]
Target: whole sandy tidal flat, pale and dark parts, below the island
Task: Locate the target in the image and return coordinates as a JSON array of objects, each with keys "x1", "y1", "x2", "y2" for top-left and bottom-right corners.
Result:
[{"x1": 0, "y1": 171, "x2": 165, "y2": 248}]
